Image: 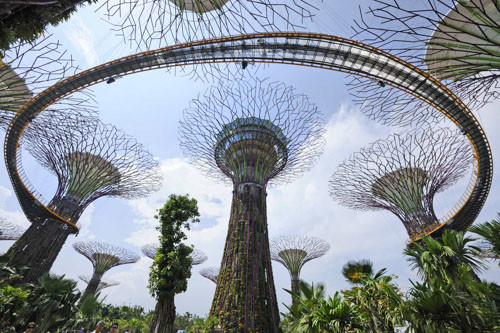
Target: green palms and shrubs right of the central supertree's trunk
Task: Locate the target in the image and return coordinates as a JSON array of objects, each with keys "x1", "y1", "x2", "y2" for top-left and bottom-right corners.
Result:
[{"x1": 281, "y1": 223, "x2": 500, "y2": 333}]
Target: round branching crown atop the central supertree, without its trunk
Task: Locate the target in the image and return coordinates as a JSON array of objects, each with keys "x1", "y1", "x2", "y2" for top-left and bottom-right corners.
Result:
[{"x1": 180, "y1": 79, "x2": 324, "y2": 185}]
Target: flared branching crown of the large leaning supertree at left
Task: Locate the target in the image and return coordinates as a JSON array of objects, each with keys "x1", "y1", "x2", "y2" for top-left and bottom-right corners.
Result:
[{"x1": 25, "y1": 113, "x2": 162, "y2": 223}]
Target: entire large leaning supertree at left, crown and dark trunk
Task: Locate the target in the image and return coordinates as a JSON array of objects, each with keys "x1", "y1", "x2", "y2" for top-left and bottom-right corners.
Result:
[{"x1": 7, "y1": 112, "x2": 161, "y2": 281}]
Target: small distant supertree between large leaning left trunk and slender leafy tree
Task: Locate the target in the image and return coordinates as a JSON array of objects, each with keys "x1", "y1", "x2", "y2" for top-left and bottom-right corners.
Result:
[{"x1": 73, "y1": 242, "x2": 140, "y2": 300}]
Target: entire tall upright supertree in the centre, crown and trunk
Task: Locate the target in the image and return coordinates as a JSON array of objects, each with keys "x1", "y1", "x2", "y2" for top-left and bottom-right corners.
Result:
[{"x1": 180, "y1": 79, "x2": 324, "y2": 332}]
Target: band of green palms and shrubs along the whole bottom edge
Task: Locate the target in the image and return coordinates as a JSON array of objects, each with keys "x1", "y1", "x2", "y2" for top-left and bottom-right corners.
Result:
[{"x1": 0, "y1": 215, "x2": 500, "y2": 333}]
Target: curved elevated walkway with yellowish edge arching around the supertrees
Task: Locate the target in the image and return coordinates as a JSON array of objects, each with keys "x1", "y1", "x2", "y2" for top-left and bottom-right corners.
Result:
[{"x1": 4, "y1": 33, "x2": 493, "y2": 256}]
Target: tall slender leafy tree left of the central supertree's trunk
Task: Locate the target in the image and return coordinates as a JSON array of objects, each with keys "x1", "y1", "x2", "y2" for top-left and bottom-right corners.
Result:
[{"x1": 149, "y1": 194, "x2": 200, "y2": 333}]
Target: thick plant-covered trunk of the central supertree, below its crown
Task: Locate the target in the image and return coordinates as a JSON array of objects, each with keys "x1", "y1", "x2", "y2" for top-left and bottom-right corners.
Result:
[{"x1": 210, "y1": 183, "x2": 281, "y2": 332}]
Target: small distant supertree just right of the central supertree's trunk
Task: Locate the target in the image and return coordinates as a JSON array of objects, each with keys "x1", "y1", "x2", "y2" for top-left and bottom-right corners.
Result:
[{"x1": 271, "y1": 236, "x2": 330, "y2": 302}]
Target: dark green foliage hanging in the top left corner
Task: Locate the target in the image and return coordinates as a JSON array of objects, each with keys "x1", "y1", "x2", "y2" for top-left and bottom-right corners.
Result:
[{"x1": 0, "y1": 0, "x2": 97, "y2": 56}]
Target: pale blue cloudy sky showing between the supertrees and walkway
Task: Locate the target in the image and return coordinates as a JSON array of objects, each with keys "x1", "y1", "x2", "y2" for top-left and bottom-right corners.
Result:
[{"x1": 0, "y1": 1, "x2": 500, "y2": 315}]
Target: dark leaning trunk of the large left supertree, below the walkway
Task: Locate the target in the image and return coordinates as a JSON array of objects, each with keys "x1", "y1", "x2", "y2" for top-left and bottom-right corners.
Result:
[{"x1": 7, "y1": 220, "x2": 73, "y2": 283}]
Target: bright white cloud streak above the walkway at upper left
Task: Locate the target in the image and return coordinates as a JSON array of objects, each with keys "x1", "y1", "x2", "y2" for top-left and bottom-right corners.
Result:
[{"x1": 65, "y1": 17, "x2": 99, "y2": 67}]
